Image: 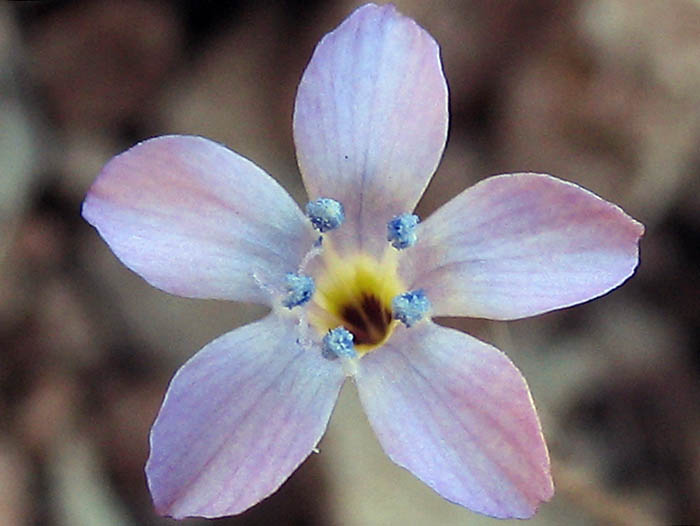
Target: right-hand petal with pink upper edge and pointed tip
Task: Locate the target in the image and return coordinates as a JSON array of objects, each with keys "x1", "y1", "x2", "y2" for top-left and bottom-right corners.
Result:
[{"x1": 402, "y1": 174, "x2": 644, "y2": 320}]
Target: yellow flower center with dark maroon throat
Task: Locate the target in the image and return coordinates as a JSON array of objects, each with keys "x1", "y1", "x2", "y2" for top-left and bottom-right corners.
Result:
[{"x1": 309, "y1": 246, "x2": 406, "y2": 356}]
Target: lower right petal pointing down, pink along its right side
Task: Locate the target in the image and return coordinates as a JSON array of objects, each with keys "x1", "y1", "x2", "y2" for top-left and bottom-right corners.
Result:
[{"x1": 356, "y1": 322, "x2": 554, "y2": 518}]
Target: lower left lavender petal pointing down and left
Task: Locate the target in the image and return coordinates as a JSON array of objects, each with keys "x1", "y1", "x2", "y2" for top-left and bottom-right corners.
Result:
[{"x1": 146, "y1": 315, "x2": 344, "y2": 518}]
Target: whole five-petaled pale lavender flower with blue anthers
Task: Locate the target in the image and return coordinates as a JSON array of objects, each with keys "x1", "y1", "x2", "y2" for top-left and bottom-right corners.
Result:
[{"x1": 83, "y1": 4, "x2": 643, "y2": 518}]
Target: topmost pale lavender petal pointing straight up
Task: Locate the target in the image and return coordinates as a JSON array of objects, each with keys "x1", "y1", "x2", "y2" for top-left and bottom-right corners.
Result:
[{"x1": 294, "y1": 4, "x2": 448, "y2": 255}]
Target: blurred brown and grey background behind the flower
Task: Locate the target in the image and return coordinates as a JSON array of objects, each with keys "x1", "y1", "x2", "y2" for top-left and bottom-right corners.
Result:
[{"x1": 0, "y1": 0, "x2": 700, "y2": 526}]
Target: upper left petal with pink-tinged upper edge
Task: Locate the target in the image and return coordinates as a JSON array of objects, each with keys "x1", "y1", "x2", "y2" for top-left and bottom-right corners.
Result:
[{"x1": 83, "y1": 136, "x2": 314, "y2": 303}]
